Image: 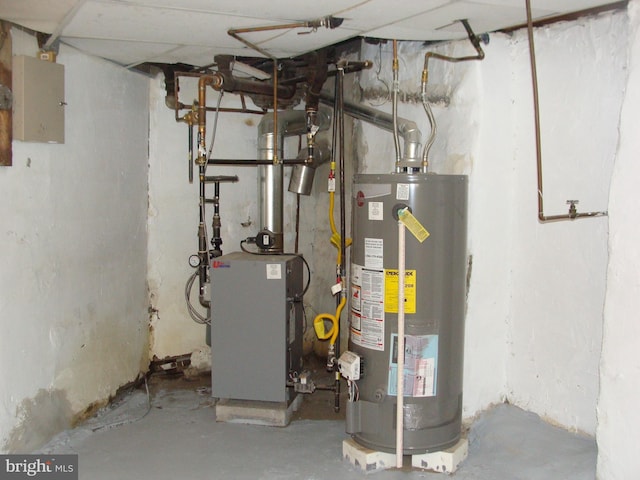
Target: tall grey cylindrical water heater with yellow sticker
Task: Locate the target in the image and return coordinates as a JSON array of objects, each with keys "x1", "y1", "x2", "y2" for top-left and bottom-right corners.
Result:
[{"x1": 348, "y1": 173, "x2": 467, "y2": 455}]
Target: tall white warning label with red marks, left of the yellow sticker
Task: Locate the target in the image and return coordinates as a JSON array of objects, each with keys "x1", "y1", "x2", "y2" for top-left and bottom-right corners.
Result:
[{"x1": 350, "y1": 265, "x2": 384, "y2": 351}]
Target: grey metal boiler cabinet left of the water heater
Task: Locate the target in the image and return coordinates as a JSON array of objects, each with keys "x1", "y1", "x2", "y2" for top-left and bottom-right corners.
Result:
[{"x1": 210, "y1": 252, "x2": 303, "y2": 402}]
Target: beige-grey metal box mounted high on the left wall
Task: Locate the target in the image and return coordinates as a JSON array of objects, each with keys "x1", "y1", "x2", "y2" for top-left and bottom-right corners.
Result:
[{"x1": 12, "y1": 55, "x2": 65, "y2": 143}]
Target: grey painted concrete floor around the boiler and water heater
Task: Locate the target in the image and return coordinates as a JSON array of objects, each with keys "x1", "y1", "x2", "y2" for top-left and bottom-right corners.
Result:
[{"x1": 41, "y1": 379, "x2": 596, "y2": 480}]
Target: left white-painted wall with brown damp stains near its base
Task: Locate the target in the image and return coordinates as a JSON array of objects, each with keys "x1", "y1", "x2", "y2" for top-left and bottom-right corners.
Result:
[{"x1": 0, "y1": 29, "x2": 148, "y2": 452}]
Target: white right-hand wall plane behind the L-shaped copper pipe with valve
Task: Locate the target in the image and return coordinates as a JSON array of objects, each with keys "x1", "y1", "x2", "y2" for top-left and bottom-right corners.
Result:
[{"x1": 507, "y1": 13, "x2": 627, "y2": 434}]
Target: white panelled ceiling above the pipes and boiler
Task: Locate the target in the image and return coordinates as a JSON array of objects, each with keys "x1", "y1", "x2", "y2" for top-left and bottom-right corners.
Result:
[{"x1": 0, "y1": 0, "x2": 612, "y2": 67}]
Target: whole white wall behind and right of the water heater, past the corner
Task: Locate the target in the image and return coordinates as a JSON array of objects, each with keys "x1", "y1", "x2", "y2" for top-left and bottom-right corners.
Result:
[{"x1": 360, "y1": 9, "x2": 626, "y2": 434}]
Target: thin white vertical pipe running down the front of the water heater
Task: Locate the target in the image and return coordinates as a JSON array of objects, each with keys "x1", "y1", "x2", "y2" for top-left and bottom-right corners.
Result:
[{"x1": 396, "y1": 220, "x2": 405, "y2": 468}]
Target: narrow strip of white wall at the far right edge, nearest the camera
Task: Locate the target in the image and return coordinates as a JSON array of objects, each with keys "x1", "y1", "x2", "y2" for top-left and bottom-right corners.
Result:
[{"x1": 597, "y1": 0, "x2": 640, "y2": 480}]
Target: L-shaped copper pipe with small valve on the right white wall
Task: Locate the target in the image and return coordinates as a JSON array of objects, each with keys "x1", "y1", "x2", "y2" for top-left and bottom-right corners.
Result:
[{"x1": 525, "y1": 0, "x2": 608, "y2": 223}]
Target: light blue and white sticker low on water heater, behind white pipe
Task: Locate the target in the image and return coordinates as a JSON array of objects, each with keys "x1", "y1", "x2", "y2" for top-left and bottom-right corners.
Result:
[{"x1": 387, "y1": 333, "x2": 438, "y2": 397}]
